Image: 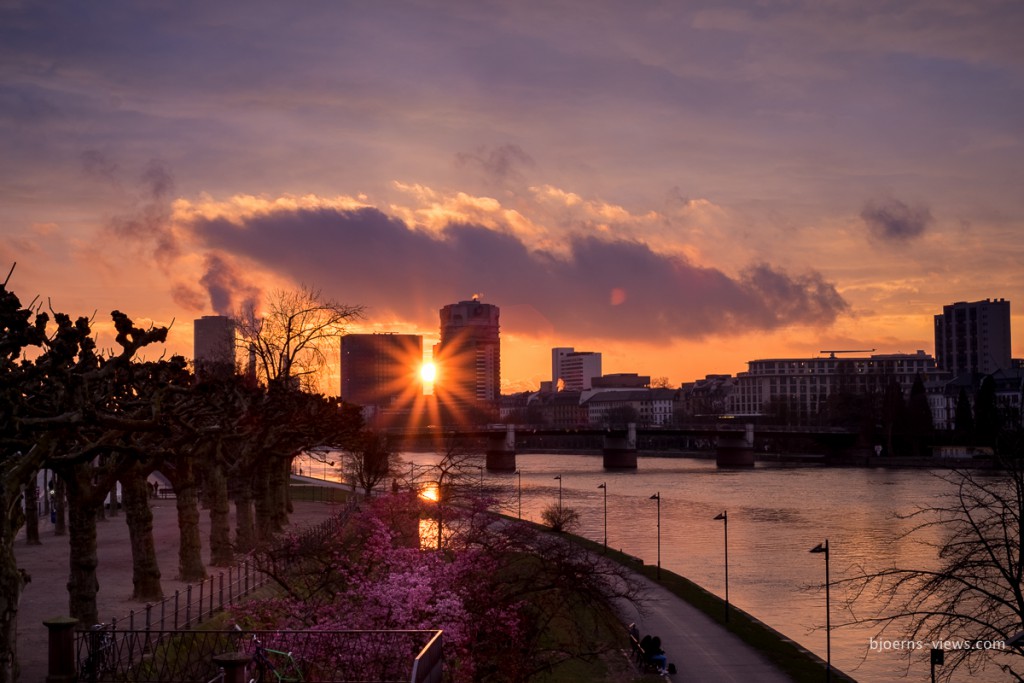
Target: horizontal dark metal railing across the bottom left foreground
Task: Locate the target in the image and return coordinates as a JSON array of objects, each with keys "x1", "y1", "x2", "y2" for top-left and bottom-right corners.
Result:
[{"x1": 76, "y1": 629, "x2": 441, "y2": 683}]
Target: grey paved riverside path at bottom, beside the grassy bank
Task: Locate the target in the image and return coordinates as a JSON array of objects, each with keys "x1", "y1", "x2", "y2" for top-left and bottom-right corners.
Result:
[{"x1": 621, "y1": 577, "x2": 793, "y2": 683}]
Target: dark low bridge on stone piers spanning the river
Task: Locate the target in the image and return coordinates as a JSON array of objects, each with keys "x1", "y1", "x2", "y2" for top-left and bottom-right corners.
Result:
[{"x1": 392, "y1": 421, "x2": 856, "y2": 472}]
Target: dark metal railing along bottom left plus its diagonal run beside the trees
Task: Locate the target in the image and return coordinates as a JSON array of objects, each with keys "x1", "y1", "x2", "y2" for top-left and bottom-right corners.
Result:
[{"x1": 47, "y1": 497, "x2": 443, "y2": 683}]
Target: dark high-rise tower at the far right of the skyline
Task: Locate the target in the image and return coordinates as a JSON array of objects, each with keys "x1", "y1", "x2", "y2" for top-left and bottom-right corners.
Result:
[{"x1": 935, "y1": 299, "x2": 1012, "y2": 377}]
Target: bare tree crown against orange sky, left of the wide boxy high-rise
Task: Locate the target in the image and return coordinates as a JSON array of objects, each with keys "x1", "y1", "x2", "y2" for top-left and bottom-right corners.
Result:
[{"x1": 236, "y1": 285, "x2": 364, "y2": 389}]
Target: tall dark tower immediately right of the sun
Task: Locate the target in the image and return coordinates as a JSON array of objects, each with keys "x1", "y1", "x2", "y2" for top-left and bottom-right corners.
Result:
[{"x1": 434, "y1": 297, "x2": 501, "y2": 410}]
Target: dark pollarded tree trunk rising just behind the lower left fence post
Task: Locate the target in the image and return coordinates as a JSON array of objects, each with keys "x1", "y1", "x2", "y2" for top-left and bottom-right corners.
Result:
[{"x1": 68, "y1": 482, "x2": 100, "y2": 626}]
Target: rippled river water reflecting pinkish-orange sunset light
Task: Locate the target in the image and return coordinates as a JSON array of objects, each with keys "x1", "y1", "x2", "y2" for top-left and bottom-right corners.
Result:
[{"x1": 385, "y1": 453, "x2": 1006, "y2": 682}]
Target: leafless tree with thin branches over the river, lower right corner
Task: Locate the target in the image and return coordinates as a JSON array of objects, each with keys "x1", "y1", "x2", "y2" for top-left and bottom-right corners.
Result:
[{"x1": 838, "y1": 443, "x2": 1024, "y2": 681}]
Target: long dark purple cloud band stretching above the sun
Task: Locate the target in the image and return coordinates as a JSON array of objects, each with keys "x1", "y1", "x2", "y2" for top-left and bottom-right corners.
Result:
[{"x1": 191, "y1": 208, "x2": 848, "y2": 340}]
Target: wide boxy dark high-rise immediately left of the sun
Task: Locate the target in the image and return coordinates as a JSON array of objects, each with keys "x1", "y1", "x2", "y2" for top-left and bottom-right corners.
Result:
[{"x1": 341, "y1": 334, "x2": 423, "y2": 408}]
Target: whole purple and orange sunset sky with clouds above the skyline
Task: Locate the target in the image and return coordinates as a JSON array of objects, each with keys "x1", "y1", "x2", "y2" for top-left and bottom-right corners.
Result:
[{"x1": 0, "y1": 0, "x2": 1024, "y2": 391}]
